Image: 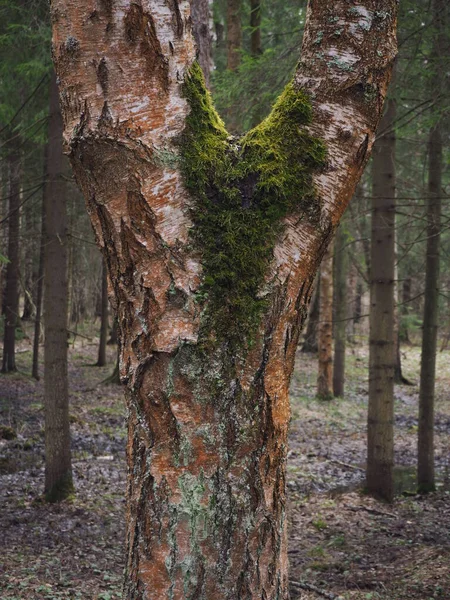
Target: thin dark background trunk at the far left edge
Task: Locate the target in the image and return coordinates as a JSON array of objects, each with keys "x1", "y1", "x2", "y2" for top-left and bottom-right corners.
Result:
[{"x1": 2, "y1": 147, "x2": 21, "y2": 373}]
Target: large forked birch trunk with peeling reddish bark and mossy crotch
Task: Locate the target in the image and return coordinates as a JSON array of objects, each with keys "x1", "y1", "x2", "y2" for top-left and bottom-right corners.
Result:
[{"x1": 52, "y1": 0, "x2": 396, "y2": 600}]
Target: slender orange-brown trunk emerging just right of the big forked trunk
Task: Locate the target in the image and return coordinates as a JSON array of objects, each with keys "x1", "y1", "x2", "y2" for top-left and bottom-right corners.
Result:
[{"x1": 317, "y1": 245, "x2": 333, "y2": 400}]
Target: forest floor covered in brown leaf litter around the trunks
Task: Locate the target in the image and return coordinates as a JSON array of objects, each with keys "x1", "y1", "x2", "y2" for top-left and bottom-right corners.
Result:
[{"x1": 0, "y1": 330, "x2": 450, "y2": 600}]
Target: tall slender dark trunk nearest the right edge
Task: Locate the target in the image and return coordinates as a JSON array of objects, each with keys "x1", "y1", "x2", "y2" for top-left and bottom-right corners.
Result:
[{"x1": 417, "y1": 123, "x2": 442, "y2": 492}]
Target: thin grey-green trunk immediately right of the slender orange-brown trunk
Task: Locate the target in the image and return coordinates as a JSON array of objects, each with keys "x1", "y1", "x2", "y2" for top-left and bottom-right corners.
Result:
[{"x1": 333, "y1": 225, "x2": 348, "y2": 397}]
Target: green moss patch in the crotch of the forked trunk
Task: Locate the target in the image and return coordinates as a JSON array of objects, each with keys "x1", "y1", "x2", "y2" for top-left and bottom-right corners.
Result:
[{"x1": 180, "y1": 63, "x2": 326, "y2": 343}]
